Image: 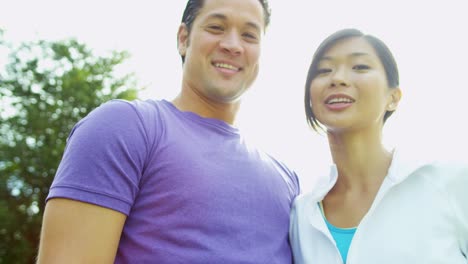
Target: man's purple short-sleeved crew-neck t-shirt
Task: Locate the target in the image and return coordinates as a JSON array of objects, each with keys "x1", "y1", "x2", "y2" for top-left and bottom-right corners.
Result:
[{"x1": 47, "y1": 100, "x2": 299, "y2": 264}]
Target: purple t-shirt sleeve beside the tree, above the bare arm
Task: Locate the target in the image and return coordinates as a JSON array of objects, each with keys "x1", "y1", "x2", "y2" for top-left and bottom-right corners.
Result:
[{"x1": 47, "y1": 100, "x2": 150, "y2": 215}]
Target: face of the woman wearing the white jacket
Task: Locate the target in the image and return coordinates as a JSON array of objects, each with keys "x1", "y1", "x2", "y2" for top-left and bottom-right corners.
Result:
[{"x1": 310, "y1": 37, "x2": 400, "y2": 132}]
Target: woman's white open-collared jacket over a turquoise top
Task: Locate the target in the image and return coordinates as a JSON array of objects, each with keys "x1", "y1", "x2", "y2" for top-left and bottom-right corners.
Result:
[{"x1": 290, "y1": 151, "x2": 468, "y2": 264}]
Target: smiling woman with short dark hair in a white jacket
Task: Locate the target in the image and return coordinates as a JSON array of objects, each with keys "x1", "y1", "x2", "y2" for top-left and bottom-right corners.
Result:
[{"x1": 290, "y1": 29, "x2": 468, "y2": 264}]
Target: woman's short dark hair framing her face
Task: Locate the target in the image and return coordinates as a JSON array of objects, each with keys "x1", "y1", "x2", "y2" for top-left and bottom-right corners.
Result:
[{"x1": 304, "y1": 28, "x2": 400, "y2": 131}]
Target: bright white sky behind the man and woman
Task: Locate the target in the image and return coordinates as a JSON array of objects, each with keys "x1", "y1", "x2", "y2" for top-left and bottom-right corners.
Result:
[{"x1": 0, "y1": 0, "x2": 468, "y2": 190}]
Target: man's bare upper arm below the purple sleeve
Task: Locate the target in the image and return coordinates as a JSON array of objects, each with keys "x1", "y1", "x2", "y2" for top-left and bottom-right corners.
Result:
[{"x1": 37, "y1": 198, "x2": 126, "y2": 264}]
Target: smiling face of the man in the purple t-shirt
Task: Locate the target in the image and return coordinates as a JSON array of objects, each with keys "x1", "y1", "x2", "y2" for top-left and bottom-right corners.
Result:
[{"x1": 178, "y1": 0, "x2": 264, "y2": 103}]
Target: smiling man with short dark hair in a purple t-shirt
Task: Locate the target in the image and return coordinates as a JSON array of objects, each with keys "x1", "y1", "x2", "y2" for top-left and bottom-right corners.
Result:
[{"x1": 38, "y1": 0, "x2": 299, "y2": 264}]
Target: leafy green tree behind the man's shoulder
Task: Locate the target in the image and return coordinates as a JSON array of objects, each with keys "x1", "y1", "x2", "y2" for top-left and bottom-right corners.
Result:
[{"x1": 0, "y1": 34, "x2": 138, "y2": 263}]
